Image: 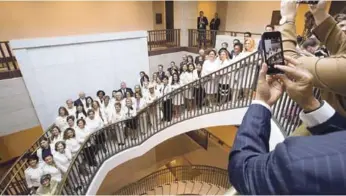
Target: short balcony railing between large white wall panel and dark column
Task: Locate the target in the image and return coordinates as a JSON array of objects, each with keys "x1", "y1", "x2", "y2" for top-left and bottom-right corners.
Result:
[{"x1": 148, "y1": 29, "x2": 180, "y2": 51}]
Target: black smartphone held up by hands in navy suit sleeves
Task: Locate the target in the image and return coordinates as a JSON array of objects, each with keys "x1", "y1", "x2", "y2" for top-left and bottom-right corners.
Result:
[{"x1": 262, "y1": 31, "x2": 285, "y2": 75}]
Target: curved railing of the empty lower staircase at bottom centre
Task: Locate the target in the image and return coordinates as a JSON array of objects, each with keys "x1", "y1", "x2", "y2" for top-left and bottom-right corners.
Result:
[{"x1": 114, "y1": 165, "x2": 231, "y2": 195}]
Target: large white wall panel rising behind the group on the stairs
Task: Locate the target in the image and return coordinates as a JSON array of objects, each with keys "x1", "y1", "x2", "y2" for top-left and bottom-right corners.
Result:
[{"x1": 10, "y1": 31, "x2": 149, "y2": 129}]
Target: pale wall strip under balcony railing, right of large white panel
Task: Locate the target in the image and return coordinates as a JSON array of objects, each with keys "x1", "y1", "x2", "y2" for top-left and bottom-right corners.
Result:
[{"x1": 149, "y1": 51, "x2": 197, "y2": 77}]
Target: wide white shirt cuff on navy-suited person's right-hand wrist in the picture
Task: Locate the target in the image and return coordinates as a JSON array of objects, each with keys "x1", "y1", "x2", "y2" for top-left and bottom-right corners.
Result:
[{"x1": 299, "y1": 101, "x2": 335, "y2": 127}]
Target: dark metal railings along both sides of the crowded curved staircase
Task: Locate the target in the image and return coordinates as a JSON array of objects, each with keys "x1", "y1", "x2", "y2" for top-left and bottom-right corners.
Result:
[{"x1": 1, "y1": 52, "x2": 320, "y2": 195}]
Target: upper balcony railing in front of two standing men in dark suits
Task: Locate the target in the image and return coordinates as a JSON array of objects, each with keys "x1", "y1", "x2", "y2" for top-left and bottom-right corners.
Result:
[{"x1": 188, "y1": 29, "x2": 261, "y2": 48}]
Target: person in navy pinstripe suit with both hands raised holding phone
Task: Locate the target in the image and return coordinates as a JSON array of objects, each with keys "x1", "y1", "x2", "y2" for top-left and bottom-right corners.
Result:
[{"x1": 228, "y1": 56, "x2": 346, "y2": 195}]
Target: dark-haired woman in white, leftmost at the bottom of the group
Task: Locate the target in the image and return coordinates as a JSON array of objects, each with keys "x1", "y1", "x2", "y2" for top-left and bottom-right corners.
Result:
[{"x1": 24, "y1": 154, "x2": 43, "y2": 193}]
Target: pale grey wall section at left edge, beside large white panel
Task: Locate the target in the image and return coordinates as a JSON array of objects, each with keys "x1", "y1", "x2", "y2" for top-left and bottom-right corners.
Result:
[{"x1": 0, "y1": 78, "x2": 40, "y2": 136}]
